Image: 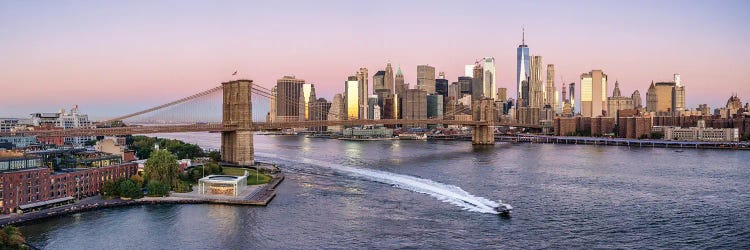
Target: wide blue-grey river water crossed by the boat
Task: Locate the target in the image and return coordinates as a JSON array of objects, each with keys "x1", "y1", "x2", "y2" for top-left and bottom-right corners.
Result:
[{"x1": 21, "y1": 133, "x2": 750, "y2": 249}]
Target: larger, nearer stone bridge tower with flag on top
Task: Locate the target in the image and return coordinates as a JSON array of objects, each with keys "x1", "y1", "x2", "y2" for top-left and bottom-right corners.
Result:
[{"x1": 221, "y1": 80, "x2": 255, "y2": 166}]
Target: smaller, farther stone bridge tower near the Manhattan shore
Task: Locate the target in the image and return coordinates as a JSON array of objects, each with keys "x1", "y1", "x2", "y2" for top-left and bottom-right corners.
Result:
[{"x1": 471, "y1": 98, "x2": 495, "y2": 145}]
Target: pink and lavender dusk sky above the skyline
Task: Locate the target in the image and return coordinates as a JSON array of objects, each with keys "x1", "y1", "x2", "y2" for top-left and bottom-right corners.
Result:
[{"x1": 0, "y1": 0, "x2": 750, "y2": 118}]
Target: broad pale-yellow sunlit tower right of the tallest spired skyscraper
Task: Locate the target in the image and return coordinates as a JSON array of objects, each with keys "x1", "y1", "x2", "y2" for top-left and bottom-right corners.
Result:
[{"x1": 581, "y1": 69, "x2": 607, "y2": 117}]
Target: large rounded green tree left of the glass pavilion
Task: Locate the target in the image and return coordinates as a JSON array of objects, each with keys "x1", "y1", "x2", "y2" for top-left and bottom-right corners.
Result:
[{"x1": 143, "y1": 150, "x2": 180, "y2": 189}]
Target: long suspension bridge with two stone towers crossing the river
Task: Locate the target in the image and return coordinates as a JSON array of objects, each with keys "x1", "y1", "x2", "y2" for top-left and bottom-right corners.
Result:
[{"x1": 0, "y1": 80, "x2": 533, "y2": 165}]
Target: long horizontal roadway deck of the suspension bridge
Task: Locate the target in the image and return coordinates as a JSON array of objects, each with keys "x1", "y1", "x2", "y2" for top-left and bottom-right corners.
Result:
[{"x1": 0, "y1": 119, "x2": 538, "y2": 137}]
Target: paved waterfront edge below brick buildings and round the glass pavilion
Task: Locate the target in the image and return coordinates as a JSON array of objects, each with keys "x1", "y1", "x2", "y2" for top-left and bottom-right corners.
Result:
[{"x1": 0, "y1": 173, "x2": 284, "y2": 227}]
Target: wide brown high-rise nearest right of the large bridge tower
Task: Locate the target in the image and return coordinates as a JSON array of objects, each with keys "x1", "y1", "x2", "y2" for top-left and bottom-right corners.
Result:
[{"x1": 276, "y1": 76, "x2": 305, "y2": 122}]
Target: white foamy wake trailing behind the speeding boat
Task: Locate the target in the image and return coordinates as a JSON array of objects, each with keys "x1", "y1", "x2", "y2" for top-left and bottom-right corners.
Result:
[{"x1": 255, "y1": 152, "x2": 512, "y2": 214}]
